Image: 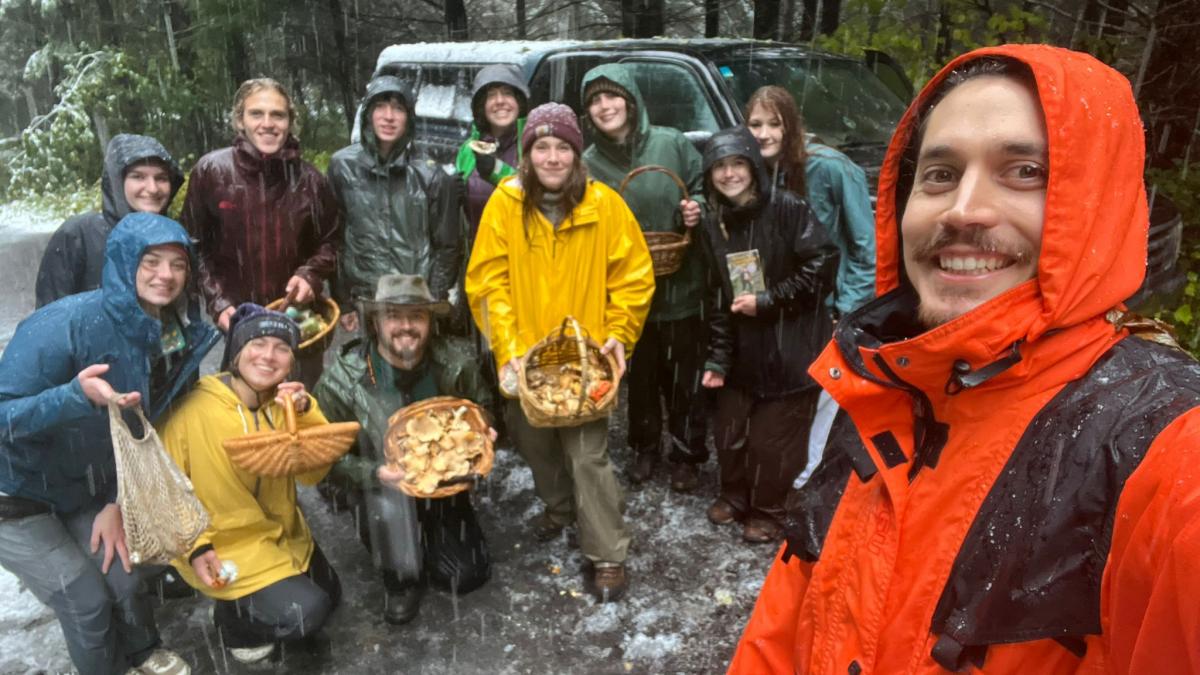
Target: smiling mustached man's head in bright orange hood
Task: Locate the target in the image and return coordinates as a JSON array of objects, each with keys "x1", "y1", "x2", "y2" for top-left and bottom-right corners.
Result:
[{"x1": 876, "y1": 46, "x2": 1148, "y2": 340}]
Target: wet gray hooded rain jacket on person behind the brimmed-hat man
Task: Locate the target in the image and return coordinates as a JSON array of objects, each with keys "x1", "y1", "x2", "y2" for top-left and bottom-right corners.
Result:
[{"x1": 329, "y1": 76, "x2": 462, "y2": 311}]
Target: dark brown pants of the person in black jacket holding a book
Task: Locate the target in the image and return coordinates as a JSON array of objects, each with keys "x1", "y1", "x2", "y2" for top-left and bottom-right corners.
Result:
[{"x1": 713, "y1": 387, "x2": 820, "y2": 524}]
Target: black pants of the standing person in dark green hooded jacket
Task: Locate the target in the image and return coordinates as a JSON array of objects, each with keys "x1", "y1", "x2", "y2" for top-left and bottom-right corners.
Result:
[{"x1": 629, "y1": 317, "x2": 708, "y2": 464}]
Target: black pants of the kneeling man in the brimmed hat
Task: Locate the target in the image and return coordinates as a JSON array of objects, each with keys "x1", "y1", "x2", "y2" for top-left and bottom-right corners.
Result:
[{"x1": 358, "y1": 492, "x2": 492, "y2": 593}]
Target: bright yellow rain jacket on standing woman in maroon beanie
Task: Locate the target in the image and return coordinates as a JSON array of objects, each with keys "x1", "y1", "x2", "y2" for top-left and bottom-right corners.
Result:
[{"x1": 466, "y1": 177, "x2": 654, "y2": 366}]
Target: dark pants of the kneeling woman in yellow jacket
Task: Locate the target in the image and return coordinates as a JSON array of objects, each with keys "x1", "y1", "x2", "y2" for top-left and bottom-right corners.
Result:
[{"x1": 212, "y1": 543, "x2": 342, "y2": 647}]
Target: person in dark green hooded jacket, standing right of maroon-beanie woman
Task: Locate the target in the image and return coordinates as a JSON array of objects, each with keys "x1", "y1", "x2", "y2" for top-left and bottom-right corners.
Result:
[{"x1": 582, "y1": 64, "x2": 708, "y2": 492}]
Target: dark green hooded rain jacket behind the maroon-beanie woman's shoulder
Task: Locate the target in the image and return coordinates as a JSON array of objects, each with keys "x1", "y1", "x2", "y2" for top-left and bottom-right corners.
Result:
[{"x1": 580, "y1": 64, "x2": 704, "y2": 321}]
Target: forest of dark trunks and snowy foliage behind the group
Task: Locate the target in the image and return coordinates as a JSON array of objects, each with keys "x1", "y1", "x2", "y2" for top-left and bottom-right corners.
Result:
[{"x1": 0, "y1": 0, "x2": 1200, "y2": 338}]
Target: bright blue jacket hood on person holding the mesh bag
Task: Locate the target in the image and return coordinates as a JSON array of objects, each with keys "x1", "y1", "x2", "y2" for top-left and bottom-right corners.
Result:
[{"x1": 101, "y1": 213, "x2": 200, "y2": 339}]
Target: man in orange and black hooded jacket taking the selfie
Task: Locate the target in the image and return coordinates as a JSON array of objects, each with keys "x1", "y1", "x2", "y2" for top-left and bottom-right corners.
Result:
[{"x1": 730, "y1": 46, "x2": 1200, "y2": 675}]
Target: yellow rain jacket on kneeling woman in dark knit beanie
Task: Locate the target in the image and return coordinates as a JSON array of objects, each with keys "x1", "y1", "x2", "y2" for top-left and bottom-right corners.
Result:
[{"x1": 160, "y1": 375, "x2": 329, "y2": 601}]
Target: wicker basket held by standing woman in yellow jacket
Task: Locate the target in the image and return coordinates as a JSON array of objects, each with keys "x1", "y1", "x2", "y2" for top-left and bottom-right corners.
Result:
[{"x1": 517, "y1": 316, "x2": 620, "y2": 428}]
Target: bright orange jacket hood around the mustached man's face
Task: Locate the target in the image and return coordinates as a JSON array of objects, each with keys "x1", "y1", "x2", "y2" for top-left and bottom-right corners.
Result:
[{"x1": 878, "y1": 44, "x2": 1148, "y2": 342}]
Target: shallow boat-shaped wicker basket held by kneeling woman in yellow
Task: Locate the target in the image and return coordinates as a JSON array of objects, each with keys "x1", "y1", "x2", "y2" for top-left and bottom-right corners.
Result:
[{"x1": 221, "y1": 396, "x2": 360, "y2": 478}]
